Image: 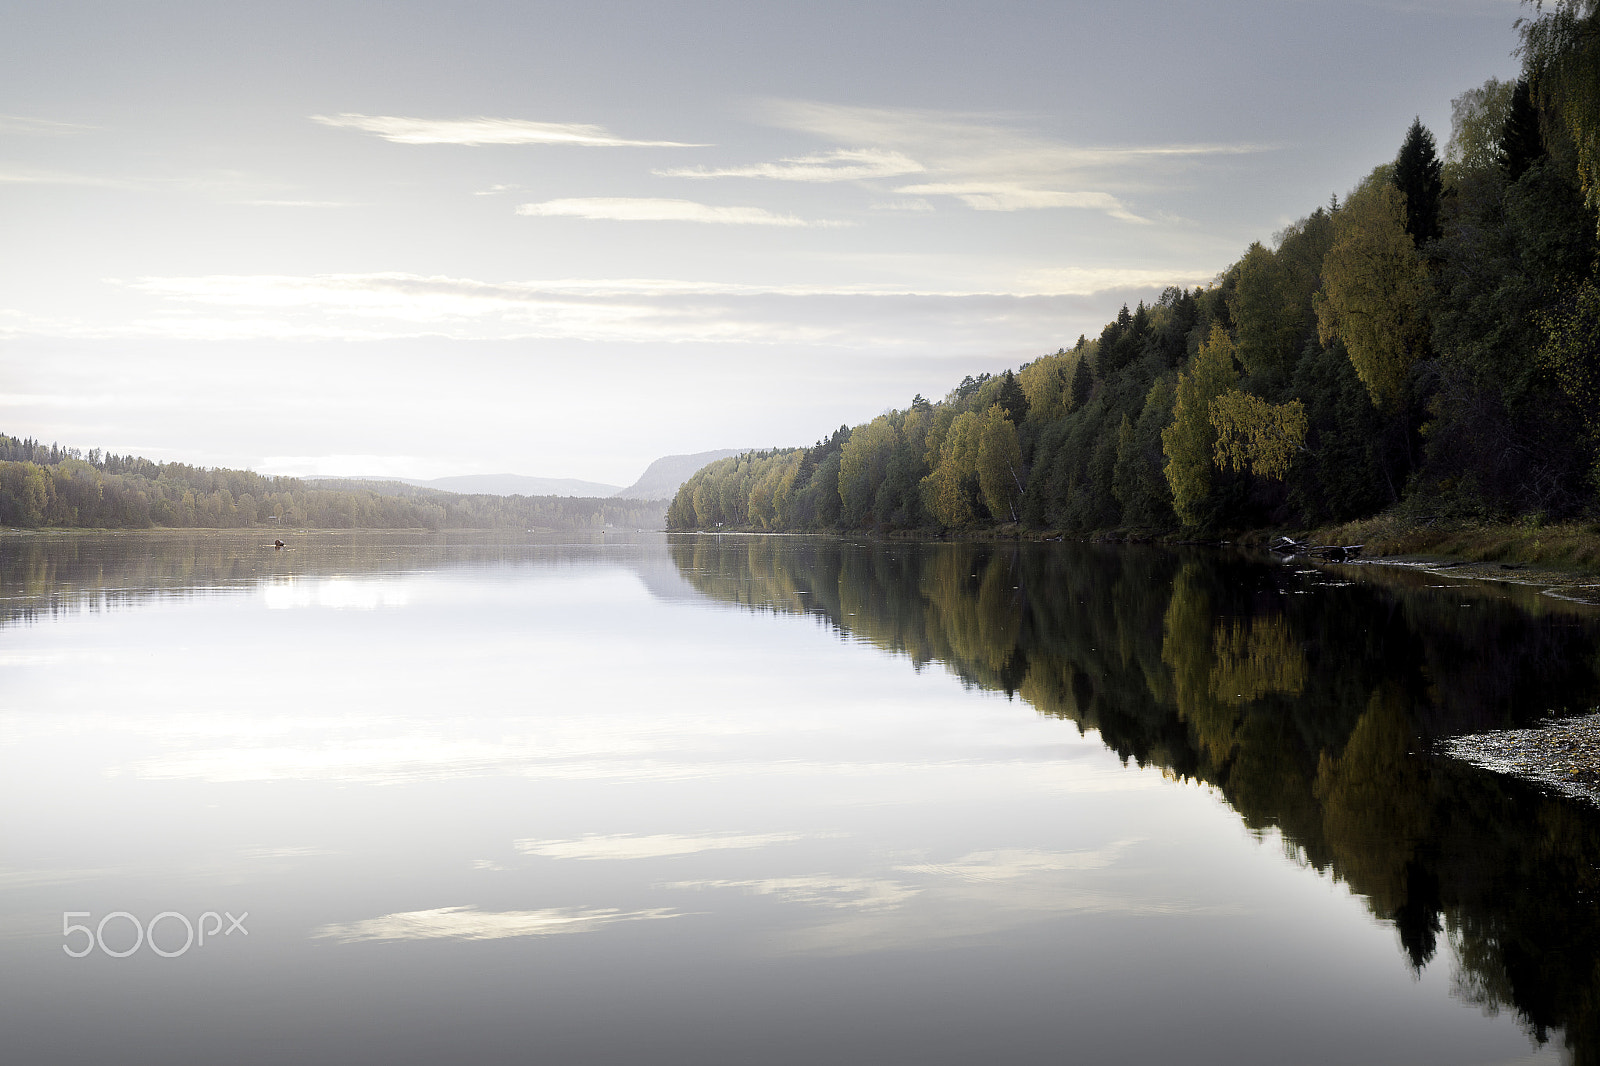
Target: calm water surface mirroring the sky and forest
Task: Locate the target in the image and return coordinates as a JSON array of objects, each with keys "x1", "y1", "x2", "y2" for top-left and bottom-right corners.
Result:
[{"x1": 0, "y1": 535, "x2": 1600, "y2": 1064}]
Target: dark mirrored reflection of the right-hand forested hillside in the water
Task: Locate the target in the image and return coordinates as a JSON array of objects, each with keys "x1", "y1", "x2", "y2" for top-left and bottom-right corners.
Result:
[{"x1": 670, "y1": 536, "x2": 1600, "y2": 1063}]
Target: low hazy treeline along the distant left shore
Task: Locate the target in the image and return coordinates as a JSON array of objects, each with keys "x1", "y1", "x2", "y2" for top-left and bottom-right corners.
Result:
[{"x1": 0, "y1": 434, "x2": 662, "y2": 530}]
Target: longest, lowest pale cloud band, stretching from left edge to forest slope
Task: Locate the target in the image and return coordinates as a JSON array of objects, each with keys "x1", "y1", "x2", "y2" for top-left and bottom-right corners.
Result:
[{"x1": 0, "y1": 270, "x2": 1214, "y2": 348}]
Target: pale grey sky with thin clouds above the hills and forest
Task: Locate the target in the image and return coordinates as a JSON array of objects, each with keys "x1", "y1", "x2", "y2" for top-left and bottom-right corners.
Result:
[{"x1": 0, "y1": 0, "x2": 1528, "y2": 485}]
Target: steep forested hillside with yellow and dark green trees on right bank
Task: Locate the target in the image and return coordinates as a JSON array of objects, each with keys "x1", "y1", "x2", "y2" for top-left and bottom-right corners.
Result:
[{"x1": 667, "y1": 0, "x2": 1600, "y2": 535}]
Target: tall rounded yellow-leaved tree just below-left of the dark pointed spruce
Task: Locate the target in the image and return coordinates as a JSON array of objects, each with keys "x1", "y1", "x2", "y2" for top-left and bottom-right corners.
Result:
[{"x1": 1315, "y1": 166, "x2": 1427, "y2": 410}]
